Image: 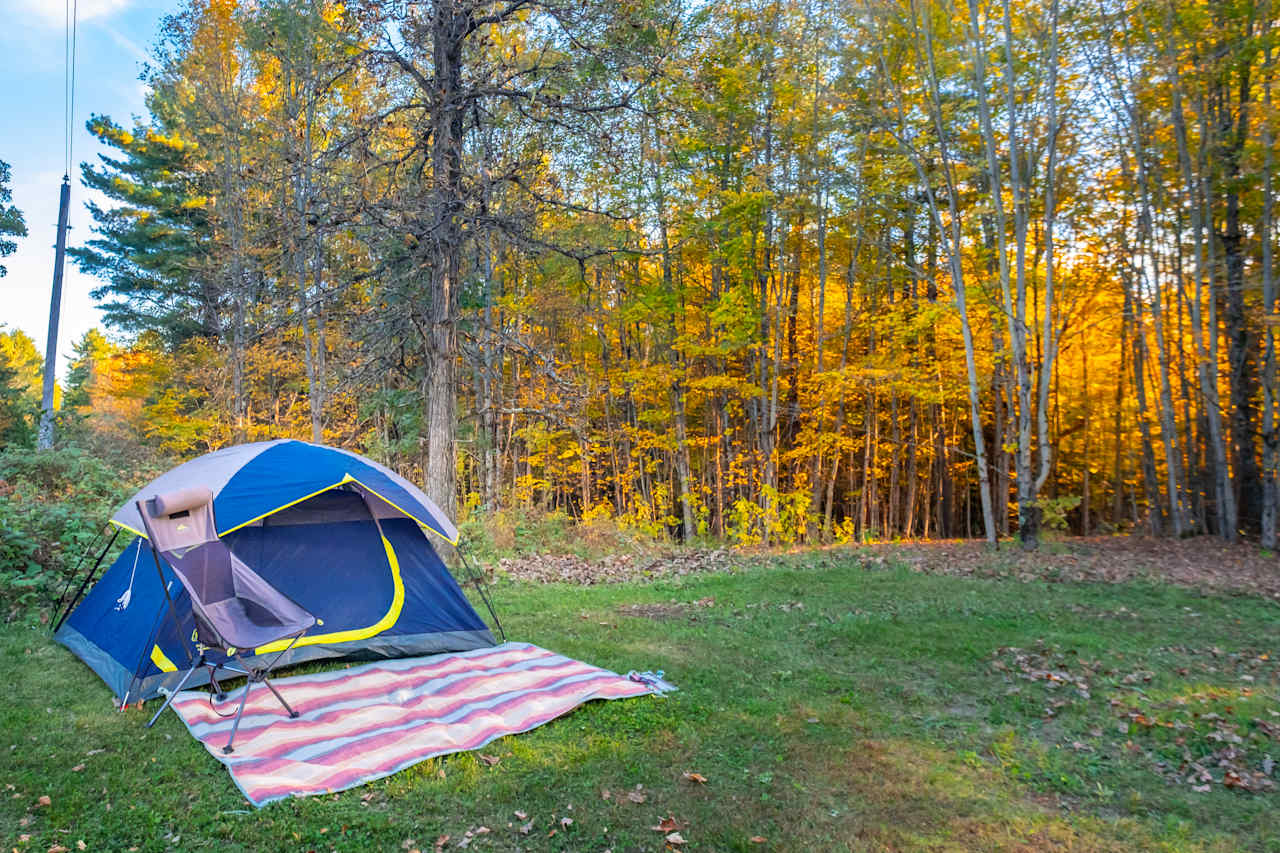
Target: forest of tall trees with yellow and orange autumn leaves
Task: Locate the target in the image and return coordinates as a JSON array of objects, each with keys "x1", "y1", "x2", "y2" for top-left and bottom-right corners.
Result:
[{"x1": 0, "y1": 0, "x2": 1280, "y2": 548}]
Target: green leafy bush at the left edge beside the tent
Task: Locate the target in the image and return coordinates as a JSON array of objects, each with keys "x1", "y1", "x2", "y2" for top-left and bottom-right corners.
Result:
[{"x1": 0, "y1": 446, "x2": 165, "y2": 612}]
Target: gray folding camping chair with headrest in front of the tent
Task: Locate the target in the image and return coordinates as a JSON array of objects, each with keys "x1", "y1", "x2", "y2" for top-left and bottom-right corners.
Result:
[{"x1": 137, "y1": 487, "x2": 316, "y2": 753}]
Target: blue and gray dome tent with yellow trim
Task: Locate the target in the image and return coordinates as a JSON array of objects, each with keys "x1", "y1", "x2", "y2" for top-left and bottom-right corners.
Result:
[{"x1": 54, "y1": 439, "x2": 500, "y2": 704}]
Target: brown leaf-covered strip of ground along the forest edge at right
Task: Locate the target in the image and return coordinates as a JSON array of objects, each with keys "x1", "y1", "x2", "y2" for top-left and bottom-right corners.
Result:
[{"x1": 861, "y1": 537, "x2": 1280, "y2": 601}]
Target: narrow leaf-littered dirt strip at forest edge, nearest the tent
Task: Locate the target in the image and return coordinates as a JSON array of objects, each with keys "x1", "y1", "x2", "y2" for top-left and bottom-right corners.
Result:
[{"x1": 498, "y1": 548, "x2": 732, "y2": 587}]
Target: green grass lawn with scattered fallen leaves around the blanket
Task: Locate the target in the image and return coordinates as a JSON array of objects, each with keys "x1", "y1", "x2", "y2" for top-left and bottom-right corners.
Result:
[{"x1": 0, "y1": 551, "x2": 1280, "y2": 852}]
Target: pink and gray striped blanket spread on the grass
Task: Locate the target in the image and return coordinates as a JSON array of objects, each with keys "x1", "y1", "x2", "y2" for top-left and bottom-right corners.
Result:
[{"x1": 173, "y1": 643, "x2": 653, "y2": 806}]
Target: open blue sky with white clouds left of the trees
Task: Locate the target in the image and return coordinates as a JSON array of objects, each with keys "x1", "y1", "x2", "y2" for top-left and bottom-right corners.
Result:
[{"x1": 0, "y1": 0, "x2": 179, "y2": 375}]
